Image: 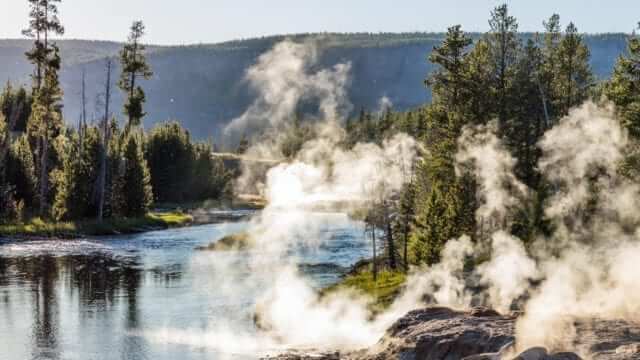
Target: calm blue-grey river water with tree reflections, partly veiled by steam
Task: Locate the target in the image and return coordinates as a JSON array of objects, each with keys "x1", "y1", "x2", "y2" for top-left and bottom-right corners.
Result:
[{"x1": 0, "y1": 214, "x2": 369, "y2": 360}]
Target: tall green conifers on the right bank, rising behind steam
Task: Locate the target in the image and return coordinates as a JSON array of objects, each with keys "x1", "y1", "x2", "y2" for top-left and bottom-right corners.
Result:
[{"x1": 346, "y1": 5, "x2": 640, "y2": 272}]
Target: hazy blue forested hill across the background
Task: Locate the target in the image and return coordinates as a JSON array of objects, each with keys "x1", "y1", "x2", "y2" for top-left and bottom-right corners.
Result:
[{"x1": 0, "y1": 33, "x2": 626, "y2": 138}]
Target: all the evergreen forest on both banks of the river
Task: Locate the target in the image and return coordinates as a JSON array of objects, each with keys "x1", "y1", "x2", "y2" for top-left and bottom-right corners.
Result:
[{"x1": 0, "y1": 0, "x2": 640, "y2": 272}]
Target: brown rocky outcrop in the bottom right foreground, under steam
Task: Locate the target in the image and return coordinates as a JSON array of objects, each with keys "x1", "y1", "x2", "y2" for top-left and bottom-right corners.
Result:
[{"x1": 264, "y1": 307, "x2": 640, "y2": 360}]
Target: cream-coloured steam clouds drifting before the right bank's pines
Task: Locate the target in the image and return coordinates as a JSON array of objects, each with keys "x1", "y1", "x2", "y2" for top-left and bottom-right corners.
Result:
[{"x1": 450, "y1": 103, "x2": 640, "y2": 356}]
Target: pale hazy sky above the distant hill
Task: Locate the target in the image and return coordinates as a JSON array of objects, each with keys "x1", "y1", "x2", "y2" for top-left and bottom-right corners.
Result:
[{"x1": 0, "y1": 0, "x2": 640, "y2": 44}]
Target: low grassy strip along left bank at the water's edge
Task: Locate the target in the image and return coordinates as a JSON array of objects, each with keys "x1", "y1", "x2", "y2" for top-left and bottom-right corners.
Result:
[{"x1": 0, "y1": 212, "x2": 193, "y2": 238}]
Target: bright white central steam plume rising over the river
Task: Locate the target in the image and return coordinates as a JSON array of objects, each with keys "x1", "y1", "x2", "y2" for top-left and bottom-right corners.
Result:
[{"x1": 147, "y1": 41, "x2": 422, "y2": 354}]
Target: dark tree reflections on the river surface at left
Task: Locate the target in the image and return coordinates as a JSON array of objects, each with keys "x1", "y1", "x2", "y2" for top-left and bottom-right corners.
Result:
[{"x1": 0, "y1": 252, "x2": 143, "y2": 359}]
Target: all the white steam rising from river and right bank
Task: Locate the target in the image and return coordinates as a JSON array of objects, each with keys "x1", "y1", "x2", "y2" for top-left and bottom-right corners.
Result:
[{"x1": 149, "y1": 41, "x2": 640, "y2": 354}]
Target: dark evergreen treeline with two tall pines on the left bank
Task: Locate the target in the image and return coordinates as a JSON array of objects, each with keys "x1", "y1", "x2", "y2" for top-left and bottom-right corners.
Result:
[{"x1": 0, "y1": 0, "x2": 230, "y2": 223}]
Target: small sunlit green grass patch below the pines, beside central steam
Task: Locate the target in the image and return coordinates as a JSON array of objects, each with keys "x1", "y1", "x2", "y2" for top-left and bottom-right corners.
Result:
[{"x1": 322, "y1": 269, "x2": 406, "y2": 314}]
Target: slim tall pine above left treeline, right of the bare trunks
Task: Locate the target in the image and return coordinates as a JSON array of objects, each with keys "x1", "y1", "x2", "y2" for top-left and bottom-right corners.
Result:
[{"x1": 118, "y1": 21, "x2": 153, "y2": 132}]
